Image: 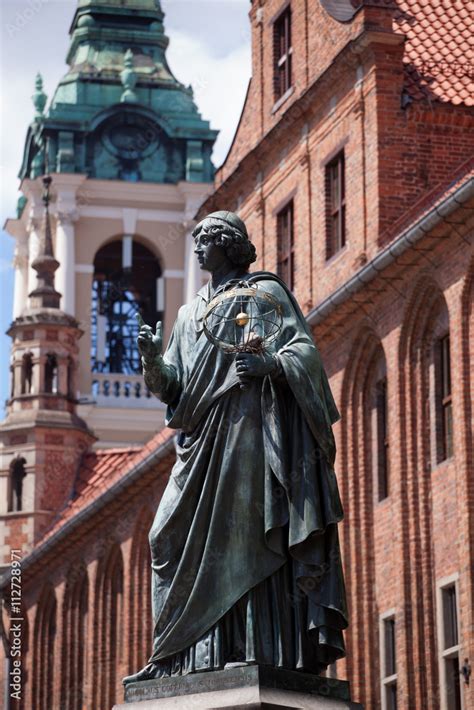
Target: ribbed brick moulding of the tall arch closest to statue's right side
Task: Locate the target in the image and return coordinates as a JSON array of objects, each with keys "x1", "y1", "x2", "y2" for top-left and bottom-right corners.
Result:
[{"x1": 338, "y1": 330, "x2": 384, "y2": 707}]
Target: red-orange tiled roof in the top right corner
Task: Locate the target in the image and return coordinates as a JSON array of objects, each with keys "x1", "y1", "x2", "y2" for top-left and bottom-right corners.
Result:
[{"x1": 390, "y1": 0, "x2": 474, "y2": 106}]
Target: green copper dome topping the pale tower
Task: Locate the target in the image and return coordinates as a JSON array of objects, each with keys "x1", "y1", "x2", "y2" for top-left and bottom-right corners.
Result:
[{"x1": 20, "y1": 0, "x2": 217, "y2": 182}]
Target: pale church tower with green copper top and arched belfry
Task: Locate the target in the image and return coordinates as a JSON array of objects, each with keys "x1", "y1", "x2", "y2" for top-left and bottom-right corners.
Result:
[{"x1": 6, "y1": 0, "x2": 217, "y2": 448}]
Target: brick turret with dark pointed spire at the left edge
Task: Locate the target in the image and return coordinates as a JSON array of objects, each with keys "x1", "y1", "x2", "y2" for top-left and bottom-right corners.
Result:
[{"x1": 0, "y1": 176, "x2": 94, "y2": 564}]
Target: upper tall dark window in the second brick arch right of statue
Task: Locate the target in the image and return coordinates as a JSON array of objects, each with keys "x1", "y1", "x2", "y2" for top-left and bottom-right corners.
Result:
[{"x1": 435, "y1": 334, "x2": 453, "y2": 462}]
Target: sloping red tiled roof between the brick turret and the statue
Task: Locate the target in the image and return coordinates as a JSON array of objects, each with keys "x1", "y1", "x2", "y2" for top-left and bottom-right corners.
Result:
[{"x1": 39, "y1": 429, "x2": 176, "y2": 544}]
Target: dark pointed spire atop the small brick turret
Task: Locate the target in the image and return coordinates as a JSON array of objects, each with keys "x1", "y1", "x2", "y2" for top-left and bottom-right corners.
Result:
[{"x1": 30, "y1": 175, "x2": 61, "y2": 309}]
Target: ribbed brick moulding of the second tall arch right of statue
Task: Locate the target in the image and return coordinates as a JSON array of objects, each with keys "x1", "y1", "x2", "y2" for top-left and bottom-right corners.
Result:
[{"x1": 398, "y1": 274, "x2": 449, "y2": 697}]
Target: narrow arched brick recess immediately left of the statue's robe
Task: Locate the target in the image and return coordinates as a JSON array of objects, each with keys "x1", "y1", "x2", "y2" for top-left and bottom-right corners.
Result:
[{"x1": 128, "y1": 512, "x2": 153, "y2": 673}]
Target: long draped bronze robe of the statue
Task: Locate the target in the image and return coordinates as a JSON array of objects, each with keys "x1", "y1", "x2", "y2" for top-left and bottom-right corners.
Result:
[{"x1": 145, "y1": 272, "x2": 347, "y2": 675}]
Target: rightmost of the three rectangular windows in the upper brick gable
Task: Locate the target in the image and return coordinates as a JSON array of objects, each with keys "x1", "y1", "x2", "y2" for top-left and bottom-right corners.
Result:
[{"x1": 326, "y1": 151, "x2": 346, "y2": 259}]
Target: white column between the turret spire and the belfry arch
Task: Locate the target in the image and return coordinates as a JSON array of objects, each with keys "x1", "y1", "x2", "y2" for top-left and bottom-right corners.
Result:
[{"x1": 55, "y1": 208, "x2": 78, "y2": 316}]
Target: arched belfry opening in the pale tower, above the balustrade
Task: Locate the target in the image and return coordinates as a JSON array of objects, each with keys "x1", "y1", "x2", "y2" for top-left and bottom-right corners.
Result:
[{"x1": 91, "y1": 236, "x2": 164, "y2": 374}]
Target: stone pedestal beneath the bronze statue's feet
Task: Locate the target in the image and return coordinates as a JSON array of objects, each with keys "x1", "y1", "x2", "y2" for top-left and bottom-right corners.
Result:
[{"x1": 114, "y1": 665, "x2": 362, "y2": 710}]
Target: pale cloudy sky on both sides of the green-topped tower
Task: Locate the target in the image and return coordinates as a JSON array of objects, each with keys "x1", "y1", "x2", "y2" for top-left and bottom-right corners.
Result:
[{"x1": 0, "y1": 0, "x2": 251, "y2": 417}]
